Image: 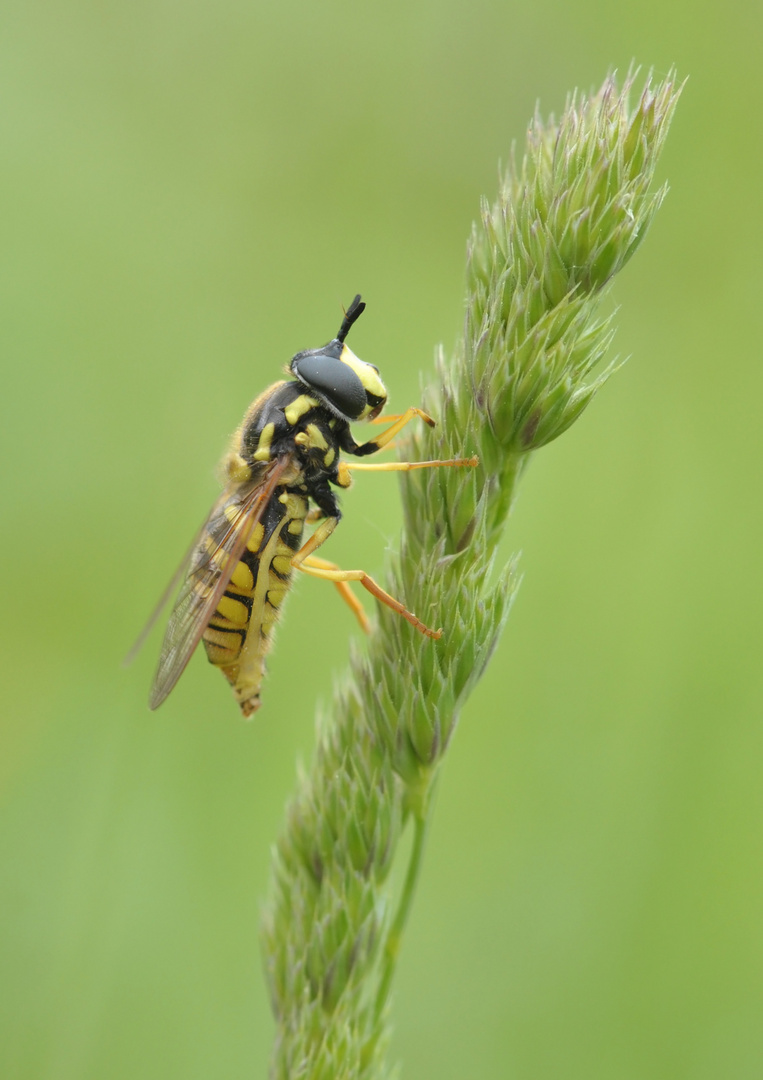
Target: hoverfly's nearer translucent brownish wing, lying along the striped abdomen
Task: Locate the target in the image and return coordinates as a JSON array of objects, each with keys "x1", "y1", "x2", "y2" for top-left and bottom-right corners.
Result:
[{"x1": 145, "y1": 458, "x2": 289, "y2": 708}]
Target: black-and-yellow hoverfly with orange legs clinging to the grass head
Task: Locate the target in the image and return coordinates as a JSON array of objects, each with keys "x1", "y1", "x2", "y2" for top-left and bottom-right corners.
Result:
[{"x1": 129, "y1": 296, "x2": 479, "y2": 716}]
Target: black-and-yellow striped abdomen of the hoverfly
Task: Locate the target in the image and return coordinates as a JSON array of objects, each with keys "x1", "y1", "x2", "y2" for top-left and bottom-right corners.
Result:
[{"x1": 203, "y1": 488, "x2": 307, "y2": 716}]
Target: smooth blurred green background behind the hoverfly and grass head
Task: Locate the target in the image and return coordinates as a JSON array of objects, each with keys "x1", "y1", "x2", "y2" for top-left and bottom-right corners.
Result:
[{"x1": 0, "y1": 0, "x2": 763, "y2": 1080}]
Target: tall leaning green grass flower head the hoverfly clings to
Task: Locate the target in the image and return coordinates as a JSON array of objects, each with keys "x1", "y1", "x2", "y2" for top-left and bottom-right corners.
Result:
[{"x1": 263, "y1": 72, "x2": 681, "y2": 1080}]
